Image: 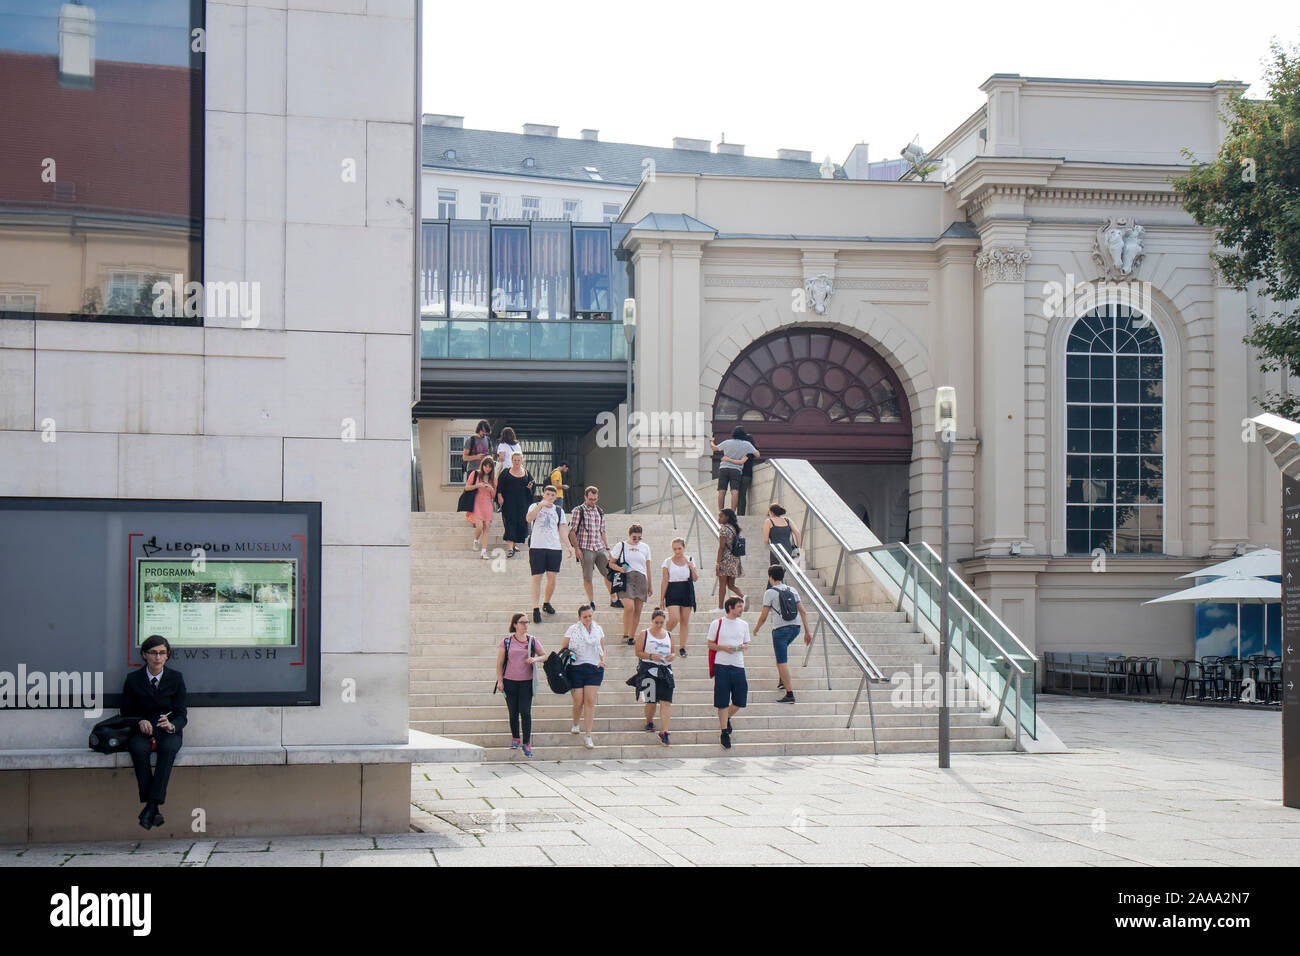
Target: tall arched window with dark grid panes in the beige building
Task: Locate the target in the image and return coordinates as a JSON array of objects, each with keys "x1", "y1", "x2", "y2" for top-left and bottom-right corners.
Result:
[{"x1": 1065, "y1": 304, "x2": 1165, "y2": 554}]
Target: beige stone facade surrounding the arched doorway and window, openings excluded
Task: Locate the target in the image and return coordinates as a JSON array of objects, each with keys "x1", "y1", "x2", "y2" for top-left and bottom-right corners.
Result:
[{"x1": 623, "y1": 74, "x2": 1281, "y2": 657}]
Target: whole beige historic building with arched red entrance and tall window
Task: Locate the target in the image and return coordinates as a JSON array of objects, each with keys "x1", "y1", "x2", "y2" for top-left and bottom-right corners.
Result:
[{"x1": 616, "y1": 74, "x2": 1286, "y2": 658}]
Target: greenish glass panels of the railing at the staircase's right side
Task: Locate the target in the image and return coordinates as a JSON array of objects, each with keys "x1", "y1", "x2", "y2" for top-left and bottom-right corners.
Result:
[{"x1": 870, "y1": 542, "x2": 1037, "y2": 739}]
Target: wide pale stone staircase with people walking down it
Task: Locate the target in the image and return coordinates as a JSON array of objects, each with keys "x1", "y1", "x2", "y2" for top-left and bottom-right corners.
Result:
[{"x1": 411, "y1": 497, "x2": 1014, "y2": 760}]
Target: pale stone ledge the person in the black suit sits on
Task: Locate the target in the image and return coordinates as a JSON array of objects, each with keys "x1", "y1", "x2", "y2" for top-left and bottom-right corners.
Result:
[{"x1": 0, "y1": 730, "x2": 484, "y2": 770}]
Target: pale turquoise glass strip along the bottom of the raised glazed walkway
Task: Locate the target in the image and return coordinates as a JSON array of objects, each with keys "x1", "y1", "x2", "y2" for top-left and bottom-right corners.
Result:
[{"x1": 420, "y1": 319, "x2": 628, "y2": 362}]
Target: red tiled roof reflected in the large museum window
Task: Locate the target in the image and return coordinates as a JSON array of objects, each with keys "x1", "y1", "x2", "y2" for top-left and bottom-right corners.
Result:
[{"x1": 0, "y1": 52, "x2": 202, "y2": 219}]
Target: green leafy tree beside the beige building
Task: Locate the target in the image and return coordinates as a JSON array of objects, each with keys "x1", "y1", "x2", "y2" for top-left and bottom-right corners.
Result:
[{"x1": 1174, "y1": 42, "x2": 1300, "y2": 418}]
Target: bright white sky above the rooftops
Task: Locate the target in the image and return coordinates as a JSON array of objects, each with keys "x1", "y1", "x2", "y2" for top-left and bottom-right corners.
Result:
[{"x1": 423, "y1": 0, "x2": 1300, "y2": 163}]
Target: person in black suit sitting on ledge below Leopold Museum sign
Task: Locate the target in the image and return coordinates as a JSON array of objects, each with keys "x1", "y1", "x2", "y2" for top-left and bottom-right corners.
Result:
[{"x1": 122, "y1": 635, "x2": 187, "y2": 830}]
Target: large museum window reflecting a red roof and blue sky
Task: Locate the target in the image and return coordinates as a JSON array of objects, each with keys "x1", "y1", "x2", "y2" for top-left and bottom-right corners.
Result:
[{"x1": 0, "y1": 0, "x2": 202, "y2": 325}]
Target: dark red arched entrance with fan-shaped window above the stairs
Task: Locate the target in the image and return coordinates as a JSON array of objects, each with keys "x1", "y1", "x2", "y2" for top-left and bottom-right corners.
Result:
[{"x1": 714, "y1": 326, "x2": 911, "y2": 541}]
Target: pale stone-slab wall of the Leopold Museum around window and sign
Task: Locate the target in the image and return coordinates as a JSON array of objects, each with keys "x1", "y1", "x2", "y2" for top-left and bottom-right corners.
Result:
[{"x1": 0, "y1": 0, "x2": 416, "y2": 832}]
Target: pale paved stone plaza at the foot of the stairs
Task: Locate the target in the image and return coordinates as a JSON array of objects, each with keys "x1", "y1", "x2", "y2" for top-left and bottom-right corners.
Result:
[{"x1": 0, "y1": 697, "x2": 1300, "y2": 868}]
